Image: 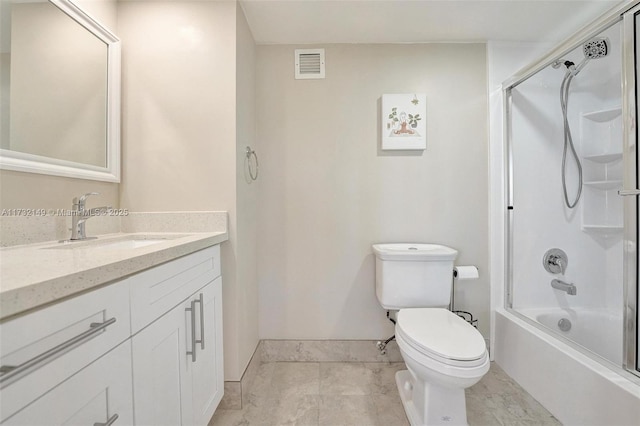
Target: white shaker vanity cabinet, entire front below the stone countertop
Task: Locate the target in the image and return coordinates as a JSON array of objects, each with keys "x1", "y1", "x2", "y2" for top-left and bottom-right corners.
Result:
[{"x1": 0, "y1": 245, "x2": 224, "y2": 426}]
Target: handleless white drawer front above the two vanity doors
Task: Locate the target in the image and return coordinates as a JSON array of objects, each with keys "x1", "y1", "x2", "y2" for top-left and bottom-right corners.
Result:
[{"x1": 127, "y1": 245, "x2": 220, "y2": 334}]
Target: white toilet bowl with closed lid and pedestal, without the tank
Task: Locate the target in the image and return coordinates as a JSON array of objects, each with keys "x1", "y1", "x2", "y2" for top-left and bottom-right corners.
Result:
[{"x1": 396, "y1": 308, "x2": 489, "y2": 426}]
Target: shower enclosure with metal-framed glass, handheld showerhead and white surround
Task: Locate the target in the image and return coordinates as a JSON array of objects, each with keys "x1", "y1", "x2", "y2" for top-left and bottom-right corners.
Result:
[{"x1": 504, "y1": 5, "x2": 640, "y2": 376}]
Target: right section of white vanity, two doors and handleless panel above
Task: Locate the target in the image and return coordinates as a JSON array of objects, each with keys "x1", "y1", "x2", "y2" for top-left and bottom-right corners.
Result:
[{"x1": 131, "y1": 246, "x2": 224, "y2": 426}]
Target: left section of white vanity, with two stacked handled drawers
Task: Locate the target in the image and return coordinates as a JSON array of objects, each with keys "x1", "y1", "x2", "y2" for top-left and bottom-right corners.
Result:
[{"x1": 0, "y1": 283, "x2": 133, "y2": 426}]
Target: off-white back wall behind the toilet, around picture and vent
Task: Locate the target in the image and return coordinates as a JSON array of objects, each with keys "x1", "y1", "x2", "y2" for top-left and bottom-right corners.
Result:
[{"x1": 257, "y1": 44, "x2": 490, "y2": 339}]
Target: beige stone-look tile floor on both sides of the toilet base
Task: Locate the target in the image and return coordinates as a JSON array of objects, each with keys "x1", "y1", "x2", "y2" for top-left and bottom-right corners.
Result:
[{"x1": 209, "y1": 362, "x2": 560, "y2": 426}]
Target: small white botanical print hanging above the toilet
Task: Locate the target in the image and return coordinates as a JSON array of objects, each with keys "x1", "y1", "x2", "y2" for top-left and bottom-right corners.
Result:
[{"x1": 382, "y1": 93, "x2": 427, "y2": 150}]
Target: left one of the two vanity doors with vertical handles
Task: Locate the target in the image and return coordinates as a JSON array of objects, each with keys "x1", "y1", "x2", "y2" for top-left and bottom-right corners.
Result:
[{"x1": 132, "y1": 302, "x2": 192, "y2": 426}]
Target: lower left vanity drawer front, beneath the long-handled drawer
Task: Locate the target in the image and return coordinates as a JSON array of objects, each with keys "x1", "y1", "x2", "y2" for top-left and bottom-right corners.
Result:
[{"x1": 2, "y1": 341, "x2": 133, "y2": 426}]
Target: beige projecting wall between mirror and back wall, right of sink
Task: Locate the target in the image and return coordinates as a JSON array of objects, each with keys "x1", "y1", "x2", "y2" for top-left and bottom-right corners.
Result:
[{"x1": 118, "y1": 1, "x2": 258, "y2": 381}]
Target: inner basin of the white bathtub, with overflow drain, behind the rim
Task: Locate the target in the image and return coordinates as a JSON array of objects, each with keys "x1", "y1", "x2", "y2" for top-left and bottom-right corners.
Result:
[{"x1": 518, "y1": 308, "x2": 623, "y2": 365}]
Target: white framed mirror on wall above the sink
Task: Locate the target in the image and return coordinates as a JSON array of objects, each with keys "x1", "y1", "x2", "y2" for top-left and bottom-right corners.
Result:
[{"x1": 0, "y1": 0, "x2": 121, "y2": 182}]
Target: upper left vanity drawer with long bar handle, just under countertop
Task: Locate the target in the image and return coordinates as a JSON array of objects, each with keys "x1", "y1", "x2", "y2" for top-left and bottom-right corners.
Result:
[{"x1": 0, "y1": 281, "x2": 130, "y2": 421}]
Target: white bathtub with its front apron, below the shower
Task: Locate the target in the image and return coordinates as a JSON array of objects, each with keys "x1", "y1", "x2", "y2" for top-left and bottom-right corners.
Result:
[{"x1": 492, "y1": 308, "x2": 640, "y2": 426}]
